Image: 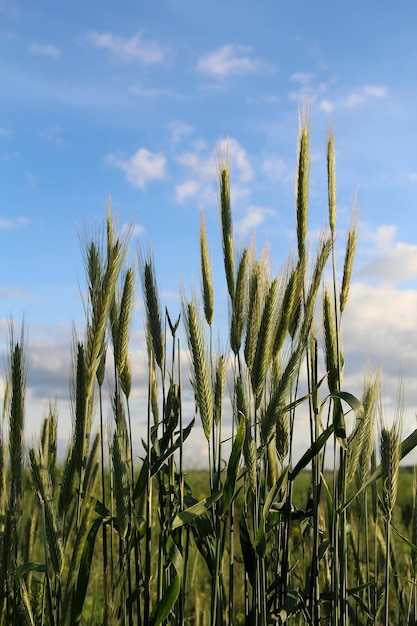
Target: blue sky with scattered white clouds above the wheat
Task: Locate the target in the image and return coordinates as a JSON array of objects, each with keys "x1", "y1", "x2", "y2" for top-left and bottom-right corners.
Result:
[{"x1": 0, "y1": 0, "x2": 417, "y2": 458}]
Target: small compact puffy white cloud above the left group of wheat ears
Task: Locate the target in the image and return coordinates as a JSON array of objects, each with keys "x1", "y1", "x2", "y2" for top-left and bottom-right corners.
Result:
[{"x1": 108, "y1": 148, "x2": 166, "y2": 189}]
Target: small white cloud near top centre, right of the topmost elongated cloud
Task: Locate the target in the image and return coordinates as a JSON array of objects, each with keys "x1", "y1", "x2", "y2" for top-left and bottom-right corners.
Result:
[{"x1": 197, "y1": 44, "x2": 263, "y2": 79}]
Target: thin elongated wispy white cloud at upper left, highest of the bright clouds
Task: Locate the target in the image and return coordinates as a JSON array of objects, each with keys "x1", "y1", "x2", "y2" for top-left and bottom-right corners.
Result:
[{"x1": 87, "y1": 31, "x2": 166, "y2": 64}]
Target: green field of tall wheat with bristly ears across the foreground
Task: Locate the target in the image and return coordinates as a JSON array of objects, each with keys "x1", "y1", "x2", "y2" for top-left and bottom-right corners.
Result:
[{"x1": 0, "y1": 116, "x2": 417, "y2": 626}]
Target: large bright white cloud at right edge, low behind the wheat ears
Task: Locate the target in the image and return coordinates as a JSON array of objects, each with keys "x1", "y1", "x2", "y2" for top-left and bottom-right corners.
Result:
[{"x1": 328, "y1": 283, "x2": 417, "y2": 454}]
